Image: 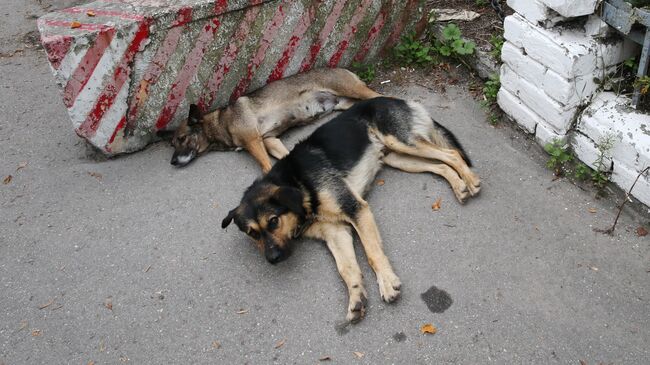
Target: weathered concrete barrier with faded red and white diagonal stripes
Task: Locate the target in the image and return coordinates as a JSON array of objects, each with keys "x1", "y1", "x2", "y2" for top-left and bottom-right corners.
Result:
[{"x1": 38, "y1": 0, "x2": 426, "y2": 155}]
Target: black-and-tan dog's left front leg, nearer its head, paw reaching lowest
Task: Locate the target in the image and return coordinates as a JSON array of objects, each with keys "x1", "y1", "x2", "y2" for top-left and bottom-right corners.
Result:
[{"x1": 307, "y1": 223, "x2": 367, "y2": 323}]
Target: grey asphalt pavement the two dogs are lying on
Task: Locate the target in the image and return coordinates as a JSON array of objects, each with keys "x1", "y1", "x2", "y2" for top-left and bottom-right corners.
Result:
[{"x1": 0, "y1": 0, "x2": 650, "y2": 365}]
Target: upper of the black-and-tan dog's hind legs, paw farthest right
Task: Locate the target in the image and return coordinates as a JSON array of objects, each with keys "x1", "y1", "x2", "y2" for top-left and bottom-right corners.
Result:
[{"x1": 382, "y1": 136, "x2": 481, "y2": 195}]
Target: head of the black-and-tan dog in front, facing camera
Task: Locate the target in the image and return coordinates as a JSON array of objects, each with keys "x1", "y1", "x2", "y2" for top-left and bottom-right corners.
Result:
[{"x1": 221, "y1": 180, "x2": 306, "y2": 264}]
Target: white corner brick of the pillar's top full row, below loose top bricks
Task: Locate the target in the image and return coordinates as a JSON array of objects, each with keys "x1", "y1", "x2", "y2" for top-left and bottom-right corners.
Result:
[{"x1": 504, "y1": 14, "x2": 638, "y2": 79}]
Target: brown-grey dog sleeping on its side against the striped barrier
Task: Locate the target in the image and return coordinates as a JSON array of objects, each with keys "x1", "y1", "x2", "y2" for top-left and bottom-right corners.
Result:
[{"x1": 171, "y1": 69, "x2": 380, "y2": 172}]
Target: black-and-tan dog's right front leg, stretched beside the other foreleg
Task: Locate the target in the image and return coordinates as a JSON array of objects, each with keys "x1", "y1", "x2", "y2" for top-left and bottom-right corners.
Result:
[{"x1": 344, "y1": 197, "x2": 402, "y2": 303}]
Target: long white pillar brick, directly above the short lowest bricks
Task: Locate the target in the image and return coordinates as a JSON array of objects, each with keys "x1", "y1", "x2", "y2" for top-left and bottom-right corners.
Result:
[{"x1": 501, "y1": 64, "x2": 577, "y2": 135}]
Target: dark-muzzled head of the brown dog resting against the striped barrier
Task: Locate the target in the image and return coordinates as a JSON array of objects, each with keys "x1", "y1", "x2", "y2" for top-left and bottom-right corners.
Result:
[{"x1": 171, "y1": 104, "x2": 210, "y2": 167}]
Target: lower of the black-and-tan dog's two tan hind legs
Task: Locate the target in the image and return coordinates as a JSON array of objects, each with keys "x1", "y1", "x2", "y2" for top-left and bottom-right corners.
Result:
[{"x1": 382, "y1": 152, "x2": 469, "y2": 203}]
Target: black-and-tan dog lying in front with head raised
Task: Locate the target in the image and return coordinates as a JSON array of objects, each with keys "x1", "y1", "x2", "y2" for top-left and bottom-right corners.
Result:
[{"x1": 222, "y1": 97, "x2": 480, "y2": 322}]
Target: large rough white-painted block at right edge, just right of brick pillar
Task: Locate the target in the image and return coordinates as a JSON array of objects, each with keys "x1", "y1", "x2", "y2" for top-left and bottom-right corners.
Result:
[{"x1": 577, "y1": 92, "x2": 650, "y2": 171}]
